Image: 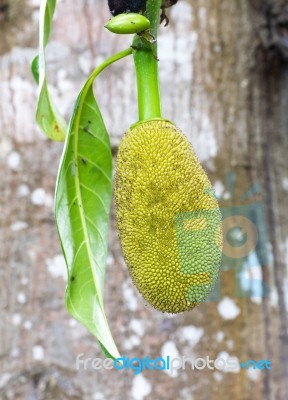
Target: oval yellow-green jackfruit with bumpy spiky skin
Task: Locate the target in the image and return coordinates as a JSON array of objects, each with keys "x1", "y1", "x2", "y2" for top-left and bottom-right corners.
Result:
[{"x1": 115, "y1": 120, "x2": 222, "y2": 313}]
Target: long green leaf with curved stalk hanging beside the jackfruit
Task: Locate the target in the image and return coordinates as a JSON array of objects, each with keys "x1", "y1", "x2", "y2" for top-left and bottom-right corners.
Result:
[{"x1": 55, "y1": 49, "x2": 132, "y2": 358}]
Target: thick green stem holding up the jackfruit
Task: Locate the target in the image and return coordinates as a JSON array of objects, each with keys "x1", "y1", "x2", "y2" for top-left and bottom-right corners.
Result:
[{"x1": 133, "y1": 0, "x2": 162, "y2": 121}]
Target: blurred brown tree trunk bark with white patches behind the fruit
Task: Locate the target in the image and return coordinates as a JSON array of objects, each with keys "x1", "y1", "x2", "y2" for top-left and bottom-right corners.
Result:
[{"x1": 0, "y1": 0, "x2": 288, "y2": 400}]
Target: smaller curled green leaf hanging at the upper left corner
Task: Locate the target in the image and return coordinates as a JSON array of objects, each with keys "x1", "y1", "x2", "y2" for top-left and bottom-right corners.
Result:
[{"x1": 31, "y1": 0, "x2": 67, "y2": 141}]
